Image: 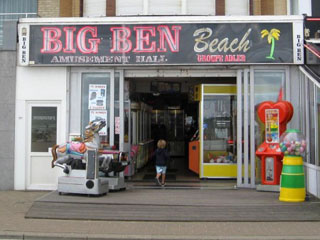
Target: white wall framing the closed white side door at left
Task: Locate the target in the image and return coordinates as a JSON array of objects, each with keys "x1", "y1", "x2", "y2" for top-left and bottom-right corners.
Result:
[{"x1": 14, "y1": 67, "x2": 68, "y2": 190}]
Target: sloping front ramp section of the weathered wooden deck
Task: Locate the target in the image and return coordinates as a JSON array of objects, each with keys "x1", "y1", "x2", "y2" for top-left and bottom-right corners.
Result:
[{"x1": 26, "y1": 202, "x2": 320, "y2": 222}]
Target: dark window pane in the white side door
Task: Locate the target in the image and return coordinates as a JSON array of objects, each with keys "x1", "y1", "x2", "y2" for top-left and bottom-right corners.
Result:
[{"x1": 31, "y1": 107, "x2": 57, "y2": 152}]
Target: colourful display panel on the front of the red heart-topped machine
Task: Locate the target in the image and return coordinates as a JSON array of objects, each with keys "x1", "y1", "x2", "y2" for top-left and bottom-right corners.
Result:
[{"x1": 265, "y1": 109, "x2": 279, "y2": 143}]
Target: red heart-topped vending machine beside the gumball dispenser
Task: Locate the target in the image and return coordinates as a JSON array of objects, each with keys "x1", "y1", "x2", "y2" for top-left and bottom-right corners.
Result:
[{"x1": 256, "y1": 101, "x2": 293, "y2": 185}]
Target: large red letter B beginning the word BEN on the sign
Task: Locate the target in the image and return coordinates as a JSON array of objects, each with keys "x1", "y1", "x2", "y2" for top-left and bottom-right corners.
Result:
[{"x1": 110, "y1": 27, "x2": 132, "y2": 53}]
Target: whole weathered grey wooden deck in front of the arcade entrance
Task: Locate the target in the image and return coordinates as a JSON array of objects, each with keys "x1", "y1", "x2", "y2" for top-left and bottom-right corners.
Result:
[{"x1": 25, "y1": 188, "x2": 320, "y2": 222}]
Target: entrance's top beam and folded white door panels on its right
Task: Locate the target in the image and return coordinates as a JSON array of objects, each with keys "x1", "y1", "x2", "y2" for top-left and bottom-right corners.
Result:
[{"x1": 124, "y1": 66, "x2": 256, "y2": 188}]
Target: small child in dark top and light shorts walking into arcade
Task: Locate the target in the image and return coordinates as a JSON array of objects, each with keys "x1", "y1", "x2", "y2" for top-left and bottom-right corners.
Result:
[{"x1": 154, "y1": 139, "x2": 170, "y2": 187}]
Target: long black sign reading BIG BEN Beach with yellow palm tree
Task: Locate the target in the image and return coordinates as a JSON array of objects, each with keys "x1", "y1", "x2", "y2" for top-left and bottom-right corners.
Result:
[{"x1": 29, "y1": 22, "x2": 303, "y2": 65}]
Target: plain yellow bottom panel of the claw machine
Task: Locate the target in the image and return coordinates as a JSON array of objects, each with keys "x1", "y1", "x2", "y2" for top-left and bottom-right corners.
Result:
[{"x1": 203, "y1": 164, "x2": 237, "y2": 178}]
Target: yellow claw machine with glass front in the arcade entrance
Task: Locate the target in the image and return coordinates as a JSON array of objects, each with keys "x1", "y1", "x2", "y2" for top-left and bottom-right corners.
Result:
[{"x1": 189, "y1": 84, "x2": 237, "y2": 178}]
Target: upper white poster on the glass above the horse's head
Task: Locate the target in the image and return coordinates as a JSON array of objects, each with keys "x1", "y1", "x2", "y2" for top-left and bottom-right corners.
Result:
[{"x1": 88, "y1": 84, "x2": 107, "y2": 109}]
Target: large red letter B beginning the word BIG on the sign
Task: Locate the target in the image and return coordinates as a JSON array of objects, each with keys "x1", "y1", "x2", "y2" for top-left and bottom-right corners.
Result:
[{"x1": 40, "y1": 27, "x2": 62, "y2": 53}]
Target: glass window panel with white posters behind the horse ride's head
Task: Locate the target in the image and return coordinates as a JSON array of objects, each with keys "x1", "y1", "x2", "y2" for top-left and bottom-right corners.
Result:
[{"x1": 81, "y1": 73, "x2": 110, "y2": 144}]
